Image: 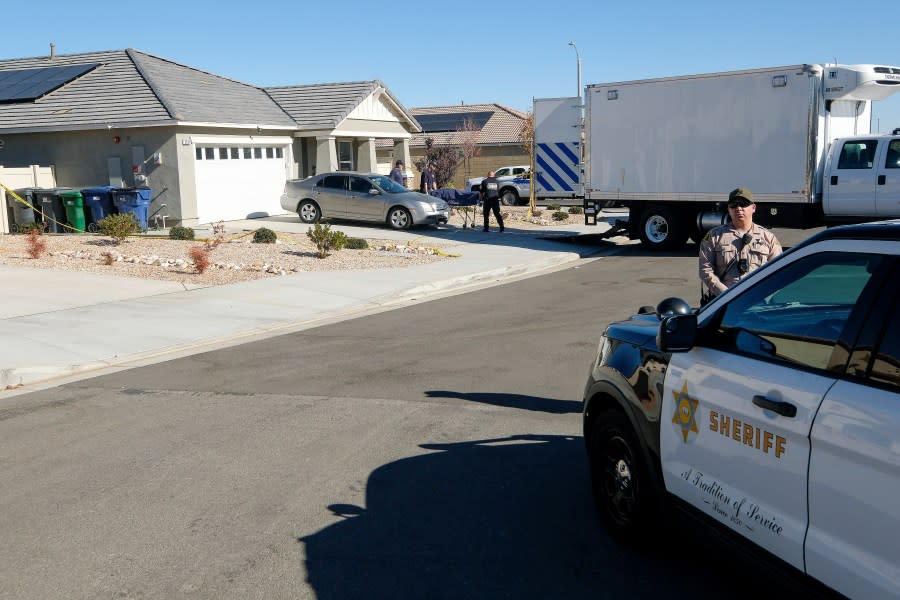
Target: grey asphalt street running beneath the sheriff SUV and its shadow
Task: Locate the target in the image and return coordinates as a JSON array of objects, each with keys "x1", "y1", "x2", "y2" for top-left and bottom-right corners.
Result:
[{"x1": 0, "y1": 229, "x2": 824, "y2": 598}]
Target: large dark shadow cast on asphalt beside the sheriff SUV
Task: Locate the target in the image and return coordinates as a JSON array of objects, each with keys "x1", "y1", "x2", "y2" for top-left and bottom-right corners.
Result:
[{"x1": 298, "y1": 435, "x2": 780, "y2": 600}]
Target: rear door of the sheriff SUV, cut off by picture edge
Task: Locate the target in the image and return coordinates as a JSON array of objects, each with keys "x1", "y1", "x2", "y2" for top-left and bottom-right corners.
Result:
[{"x1": 806, "y1": 258, "x2": 900, "y2": 598}]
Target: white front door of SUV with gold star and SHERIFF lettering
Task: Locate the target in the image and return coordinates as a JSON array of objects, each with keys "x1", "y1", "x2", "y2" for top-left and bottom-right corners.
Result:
[{"x1": 660, "y1": 241, "x2": 870, "y2": 570}]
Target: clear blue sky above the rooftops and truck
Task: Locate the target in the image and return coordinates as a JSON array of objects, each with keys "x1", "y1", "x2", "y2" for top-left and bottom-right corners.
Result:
[{"x1": 0, "y1": 0, "x2": 900, "y2": 131}]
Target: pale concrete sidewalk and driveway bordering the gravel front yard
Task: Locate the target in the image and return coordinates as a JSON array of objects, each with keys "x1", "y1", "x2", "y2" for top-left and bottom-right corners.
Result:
[{"x1": 0, "y1": 215, "x2": 609, "y2": 398}]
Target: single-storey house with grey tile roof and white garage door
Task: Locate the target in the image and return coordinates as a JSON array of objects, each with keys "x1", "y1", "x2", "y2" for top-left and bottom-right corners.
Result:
[{"x1": 0, "y1": 49, "x2": 420, "y2": 225}]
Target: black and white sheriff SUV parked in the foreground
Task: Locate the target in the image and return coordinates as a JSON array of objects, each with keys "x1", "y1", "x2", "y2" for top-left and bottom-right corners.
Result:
[{"x1": 583, "y1": 220, "x2": 900, "y2": 598}]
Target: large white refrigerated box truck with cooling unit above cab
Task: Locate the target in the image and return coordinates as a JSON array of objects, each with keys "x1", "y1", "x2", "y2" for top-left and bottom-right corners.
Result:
[{"x1": 535, "y1": 64, "x2": 900, "y2": 250}]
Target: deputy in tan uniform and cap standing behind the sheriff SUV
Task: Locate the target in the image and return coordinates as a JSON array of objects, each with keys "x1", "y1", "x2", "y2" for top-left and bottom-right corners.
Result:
[{"x1": 700, "y1": 188, "x2": 781, "y2": 304}]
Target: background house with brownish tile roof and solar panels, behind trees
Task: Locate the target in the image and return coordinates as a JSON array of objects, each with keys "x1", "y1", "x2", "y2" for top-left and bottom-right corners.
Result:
[{"x1": 400, "y1": 104, "x2": 531, "y2": 189}]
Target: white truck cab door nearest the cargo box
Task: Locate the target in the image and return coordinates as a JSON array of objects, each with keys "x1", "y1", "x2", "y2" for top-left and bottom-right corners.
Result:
[{"x1": 823, "y1": 140, "x2": 878, "y2": 217}]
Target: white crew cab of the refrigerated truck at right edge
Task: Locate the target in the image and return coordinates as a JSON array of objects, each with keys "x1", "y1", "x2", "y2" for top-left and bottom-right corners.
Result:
[{"x1": 822, "y1": 129, "x2": 900, "y2": 221}]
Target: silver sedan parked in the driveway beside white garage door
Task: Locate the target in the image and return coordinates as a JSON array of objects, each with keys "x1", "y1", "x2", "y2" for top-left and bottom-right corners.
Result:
[{"x1": 281, "y1": 171, "x2": 450, "y2": 229}]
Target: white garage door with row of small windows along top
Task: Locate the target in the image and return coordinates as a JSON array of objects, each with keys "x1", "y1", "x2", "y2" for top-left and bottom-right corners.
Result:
[{"x1": 194, "y1": 140, "x2": 290, "y2": 223}]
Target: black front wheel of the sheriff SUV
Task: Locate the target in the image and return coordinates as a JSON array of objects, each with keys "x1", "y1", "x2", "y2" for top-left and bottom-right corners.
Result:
[{"x1": 588, "y1": 409, "x2": 655, "y2": 540}]
